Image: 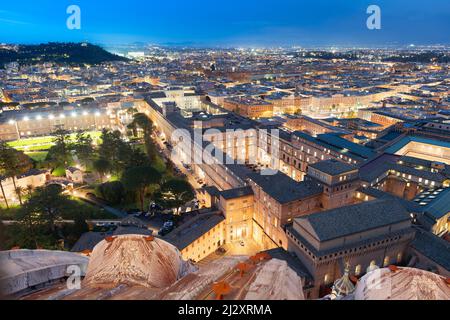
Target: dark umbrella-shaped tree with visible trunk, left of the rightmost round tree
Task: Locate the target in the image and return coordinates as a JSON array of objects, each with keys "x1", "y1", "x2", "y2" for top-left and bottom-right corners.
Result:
[{"x1": 122, "y1": 166, "x2": 161, "y2": 211}]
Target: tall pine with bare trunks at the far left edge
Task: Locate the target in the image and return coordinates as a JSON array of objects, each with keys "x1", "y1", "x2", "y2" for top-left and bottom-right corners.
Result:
[{"x1": 0, "y1": 142, "x2": 33, "y2": 204}]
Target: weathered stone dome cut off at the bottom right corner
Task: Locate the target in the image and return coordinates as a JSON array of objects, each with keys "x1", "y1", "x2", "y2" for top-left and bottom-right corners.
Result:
[{"x1": 355, "y1": 268, "x2": 450, "y2": 300}]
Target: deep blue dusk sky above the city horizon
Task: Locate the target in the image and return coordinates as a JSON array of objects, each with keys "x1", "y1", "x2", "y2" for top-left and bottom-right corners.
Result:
[{"x1": 0, "y1": 0, "x2": 450, "y2": 46}]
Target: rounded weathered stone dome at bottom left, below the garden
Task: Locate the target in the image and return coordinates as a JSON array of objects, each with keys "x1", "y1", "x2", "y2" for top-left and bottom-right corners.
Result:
[{"x1": 84, "y1": 235, "x2": 193, "y2": 289}]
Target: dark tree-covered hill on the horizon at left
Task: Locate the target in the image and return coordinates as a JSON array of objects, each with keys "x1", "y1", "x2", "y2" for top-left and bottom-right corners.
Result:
[{"x1": 0, "y1": 43, "x2": 128, "y2": 67}]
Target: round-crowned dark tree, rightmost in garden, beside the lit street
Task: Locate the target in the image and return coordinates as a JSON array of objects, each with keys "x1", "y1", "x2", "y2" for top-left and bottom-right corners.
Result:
[{"x1": 157, "y1": 179, "x2": 195, "y2": 213}]
